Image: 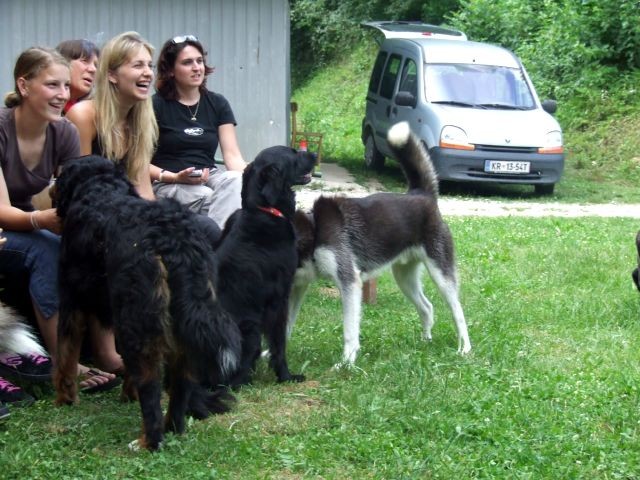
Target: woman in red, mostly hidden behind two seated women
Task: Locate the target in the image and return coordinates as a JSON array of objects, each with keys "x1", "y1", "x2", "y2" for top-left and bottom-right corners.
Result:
[{"x1": 56, "y1": 39, "x2": 100, "y2": 114}]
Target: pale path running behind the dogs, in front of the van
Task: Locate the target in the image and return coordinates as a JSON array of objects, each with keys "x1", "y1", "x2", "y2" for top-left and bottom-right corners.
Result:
[{"x1": 296, "y1": 163, "x2": 640, "y2": 218}]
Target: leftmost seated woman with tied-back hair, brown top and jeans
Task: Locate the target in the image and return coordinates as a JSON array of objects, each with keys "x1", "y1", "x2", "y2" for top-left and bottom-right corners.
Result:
[{"x1": 0, "y1": 47, "x2": 117, "y2": 404}]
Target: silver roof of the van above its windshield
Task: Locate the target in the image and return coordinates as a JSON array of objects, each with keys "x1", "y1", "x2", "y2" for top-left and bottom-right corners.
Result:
[{"x1": 402, "y1": 38, "x2": 520, "y2": 68}]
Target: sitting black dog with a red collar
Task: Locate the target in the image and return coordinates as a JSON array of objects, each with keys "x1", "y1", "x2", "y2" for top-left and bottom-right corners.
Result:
[{"x1": 217, "y1": 147, "x2": 316, "y2": 387}]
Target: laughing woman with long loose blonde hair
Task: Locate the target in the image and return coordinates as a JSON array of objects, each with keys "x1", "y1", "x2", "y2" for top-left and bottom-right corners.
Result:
[{"x1": 67, "y1": 32, "x2": 158, "y2": 199}]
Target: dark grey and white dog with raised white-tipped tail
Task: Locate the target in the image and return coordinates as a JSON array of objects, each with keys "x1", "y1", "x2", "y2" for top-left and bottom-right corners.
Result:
[{"x1": 289, "y1": 122, "x2": 471, "y2": 364}]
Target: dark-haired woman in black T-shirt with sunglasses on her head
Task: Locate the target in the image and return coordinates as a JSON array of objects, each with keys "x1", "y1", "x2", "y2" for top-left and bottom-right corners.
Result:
[{"x1": 151, "y1": 35, "x2": 246, "y2": 228}]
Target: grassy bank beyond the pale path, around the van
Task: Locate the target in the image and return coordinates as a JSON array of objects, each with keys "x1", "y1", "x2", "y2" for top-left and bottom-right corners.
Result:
[{"x1": 293, "y1": 41, "x2": 640, "y2": 203}]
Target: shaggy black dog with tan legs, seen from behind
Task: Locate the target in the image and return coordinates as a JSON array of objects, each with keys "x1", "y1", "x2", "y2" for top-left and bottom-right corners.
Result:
[{"x1": 54, "y1": 157, "x2": 241, "y2": 450}]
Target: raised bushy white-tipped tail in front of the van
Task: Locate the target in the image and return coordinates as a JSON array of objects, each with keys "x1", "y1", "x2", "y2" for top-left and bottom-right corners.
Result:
[{"x1": 387, "y1": 122, "x2": 438, "y2": 197}]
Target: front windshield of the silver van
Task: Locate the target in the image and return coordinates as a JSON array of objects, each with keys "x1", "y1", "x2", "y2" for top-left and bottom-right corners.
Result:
[{"x1": 424, "y1": 64, "x2": 535, "y2": 110}]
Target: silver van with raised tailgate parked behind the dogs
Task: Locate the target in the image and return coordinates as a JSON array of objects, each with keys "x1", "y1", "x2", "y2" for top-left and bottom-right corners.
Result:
[{"x1": 362, "y1": 22, "x2": 564, "y2": 194}]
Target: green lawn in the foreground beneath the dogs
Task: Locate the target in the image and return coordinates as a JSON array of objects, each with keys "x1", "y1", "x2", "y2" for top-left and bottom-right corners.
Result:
[{"x1": 0, "y1": 217, "x2": 640, "y2": 479}]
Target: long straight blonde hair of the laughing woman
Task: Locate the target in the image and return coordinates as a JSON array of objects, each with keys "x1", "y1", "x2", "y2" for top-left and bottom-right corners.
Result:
[{"x1": 94, "y1": 32, "x2": 158, "y2": 181}]
